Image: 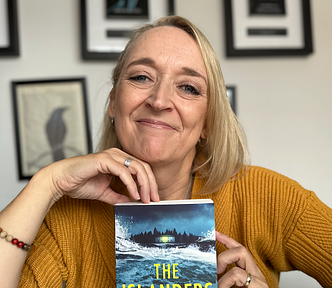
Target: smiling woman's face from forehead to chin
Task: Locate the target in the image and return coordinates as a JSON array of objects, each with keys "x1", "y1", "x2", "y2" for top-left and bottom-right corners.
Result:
[{"x1": 109, "y1": 27, "x2": 207, "y2": 165}]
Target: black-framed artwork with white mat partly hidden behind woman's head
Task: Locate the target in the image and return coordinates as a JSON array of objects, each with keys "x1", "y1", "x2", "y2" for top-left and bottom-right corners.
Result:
[{"x1": 80, "y1": 0, "x2": 174, "y2": 60}]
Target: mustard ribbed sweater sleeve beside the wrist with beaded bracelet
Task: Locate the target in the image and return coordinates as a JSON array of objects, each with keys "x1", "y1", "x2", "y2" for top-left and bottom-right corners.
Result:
[{"x1": 18, "y1": 213, "x2": 68, "y2": 288}]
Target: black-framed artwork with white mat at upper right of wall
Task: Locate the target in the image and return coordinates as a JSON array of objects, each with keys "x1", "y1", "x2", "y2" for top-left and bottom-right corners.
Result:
[{"x1": 224, "y1": 0, "x2": 313, "y2": 57}]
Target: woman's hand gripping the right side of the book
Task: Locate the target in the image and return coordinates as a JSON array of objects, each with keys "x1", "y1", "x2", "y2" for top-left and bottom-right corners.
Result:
[{"x1": 216, "y1": 231, "x2": 269, "y2": 288}]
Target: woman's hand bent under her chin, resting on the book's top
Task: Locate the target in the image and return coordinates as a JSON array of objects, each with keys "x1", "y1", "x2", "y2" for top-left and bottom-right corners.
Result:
[{"x1": 37, "y1": 148, "x2": 159, "y2": 204}]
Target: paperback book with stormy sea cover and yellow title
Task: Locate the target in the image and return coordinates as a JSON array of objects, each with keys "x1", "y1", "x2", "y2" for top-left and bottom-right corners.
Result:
[{"x1": 114, "y1": 199, "x2": 218, "y2": 288}]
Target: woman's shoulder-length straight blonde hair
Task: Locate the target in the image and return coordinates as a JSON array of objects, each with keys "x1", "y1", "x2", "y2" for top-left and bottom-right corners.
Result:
[{"x1": 98, "y1": 16, "x2": 249, "y2": 195}]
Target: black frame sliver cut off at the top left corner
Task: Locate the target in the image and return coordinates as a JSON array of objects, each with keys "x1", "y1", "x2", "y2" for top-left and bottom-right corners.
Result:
[{"x1": 0, "y1": 0, "x2": 19, "y2": 56}]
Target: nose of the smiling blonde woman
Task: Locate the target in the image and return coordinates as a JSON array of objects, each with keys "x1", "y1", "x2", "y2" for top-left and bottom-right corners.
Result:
[{"x1": 145, "y1": 80, "x2": 174, "y2": 111}]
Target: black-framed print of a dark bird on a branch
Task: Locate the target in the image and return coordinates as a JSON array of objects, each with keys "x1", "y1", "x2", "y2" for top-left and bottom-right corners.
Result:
[{"x1": 12, "y1": 78, "x2": 92, "y2": 180}]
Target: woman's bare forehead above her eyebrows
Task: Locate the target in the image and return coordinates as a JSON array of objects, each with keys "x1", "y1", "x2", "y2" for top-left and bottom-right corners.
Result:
[{"x1": 126, "y1": 26, "x2": 206, "y2": 74}]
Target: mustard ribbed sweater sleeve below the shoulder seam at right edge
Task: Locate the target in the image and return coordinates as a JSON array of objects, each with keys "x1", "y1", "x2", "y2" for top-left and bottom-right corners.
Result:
[{"x1": 284, "y1": 192, "x2": 332, "y2": 287}]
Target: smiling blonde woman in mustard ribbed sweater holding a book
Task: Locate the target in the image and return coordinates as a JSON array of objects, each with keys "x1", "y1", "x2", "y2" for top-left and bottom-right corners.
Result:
[{"x1": 0, "y1": 16, "x2": 332, "y2": 288}]
